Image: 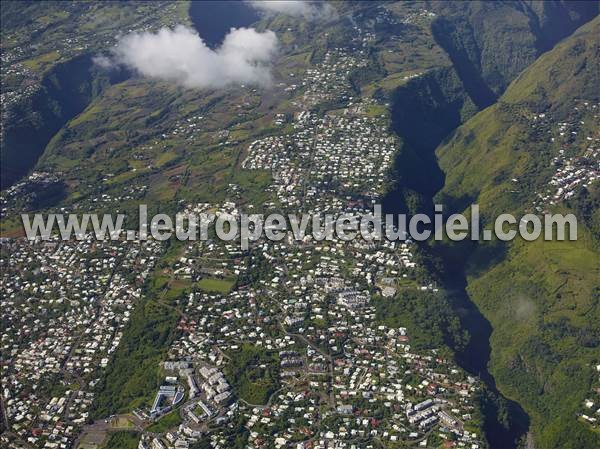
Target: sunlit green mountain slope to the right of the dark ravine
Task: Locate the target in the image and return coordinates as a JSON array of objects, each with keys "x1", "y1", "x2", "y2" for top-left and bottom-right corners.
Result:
[{"x1": 437, "y1": 19, "x2": 600, "y2": 449}]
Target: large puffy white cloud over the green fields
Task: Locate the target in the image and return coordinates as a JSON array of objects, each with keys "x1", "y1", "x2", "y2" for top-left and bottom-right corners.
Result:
[{"x1": 96, "y1": 25, "x2": 277, "y2": 88}]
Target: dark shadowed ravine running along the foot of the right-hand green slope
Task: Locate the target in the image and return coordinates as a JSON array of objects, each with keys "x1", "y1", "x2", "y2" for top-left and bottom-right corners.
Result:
[{"x1": 383, "y1": 67, "x2": 529, "y2": 449}]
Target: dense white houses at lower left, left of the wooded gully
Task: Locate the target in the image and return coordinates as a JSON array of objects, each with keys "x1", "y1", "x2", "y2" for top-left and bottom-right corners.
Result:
[{"x1": 0, "y1": 236, "x2": 161, "y2": 448}]
